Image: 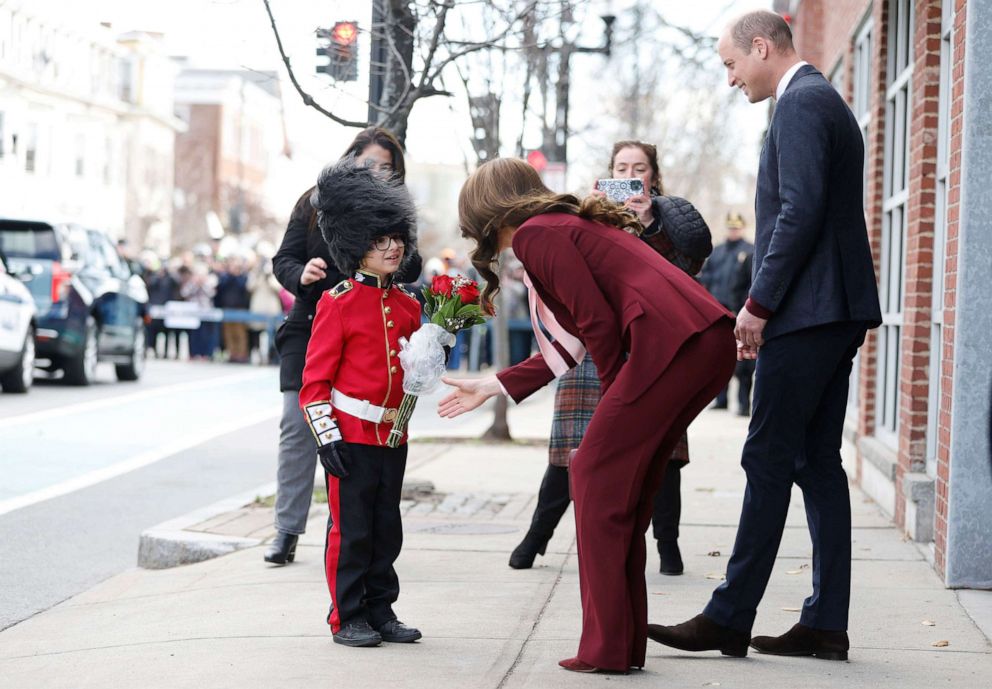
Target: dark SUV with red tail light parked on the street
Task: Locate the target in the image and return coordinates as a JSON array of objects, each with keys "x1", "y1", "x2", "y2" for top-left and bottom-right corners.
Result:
[{"x1": 0, "y1": 218, "x2": 148, "y2": 385}]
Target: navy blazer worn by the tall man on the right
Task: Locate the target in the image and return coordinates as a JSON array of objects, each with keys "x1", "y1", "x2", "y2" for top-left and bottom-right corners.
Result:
[{"x1": 750, "y1": 65, "x2": 882, "y2": 339}]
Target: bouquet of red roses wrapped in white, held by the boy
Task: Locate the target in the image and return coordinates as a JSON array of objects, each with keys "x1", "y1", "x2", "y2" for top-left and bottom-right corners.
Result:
[{"x1": 386, "y1": 275, "x2": 486, "y2": 447}]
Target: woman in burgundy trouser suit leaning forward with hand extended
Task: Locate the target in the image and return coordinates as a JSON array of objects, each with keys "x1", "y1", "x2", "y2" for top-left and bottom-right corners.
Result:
[{"x1": 438, "y1": 158, "x2": 736, "y2": 672}]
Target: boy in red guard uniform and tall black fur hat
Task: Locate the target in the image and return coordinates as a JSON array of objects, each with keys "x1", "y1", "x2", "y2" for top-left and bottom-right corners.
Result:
[{"x1": 300, "y1": 161, "x2": 421, "y2": 646}]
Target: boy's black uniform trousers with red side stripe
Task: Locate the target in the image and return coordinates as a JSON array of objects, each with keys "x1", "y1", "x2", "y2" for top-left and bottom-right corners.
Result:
[{"x1": 324, "y1": 443, "x2": 407, "y2": 632}]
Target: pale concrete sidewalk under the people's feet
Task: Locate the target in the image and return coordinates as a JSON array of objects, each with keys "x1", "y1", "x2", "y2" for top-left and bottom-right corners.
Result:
[{"x1": 0, "y1": 400, "x2": 992, "y2": 689}]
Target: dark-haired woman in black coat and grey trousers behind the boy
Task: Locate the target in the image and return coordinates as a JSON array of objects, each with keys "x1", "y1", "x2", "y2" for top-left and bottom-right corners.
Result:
[{"x1": 265, "y1": 127, "x2": 421, "y2": 565}]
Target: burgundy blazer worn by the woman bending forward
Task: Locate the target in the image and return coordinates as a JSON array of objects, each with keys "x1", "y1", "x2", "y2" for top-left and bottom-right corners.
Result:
[{"x1": 497, "y1": 213, "x2": 733, "y2": 402}]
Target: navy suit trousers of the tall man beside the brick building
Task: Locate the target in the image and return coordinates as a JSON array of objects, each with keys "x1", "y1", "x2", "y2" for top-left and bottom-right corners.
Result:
[{"x1": 703, "y1": 323, "x2": 865, "y2": 632}]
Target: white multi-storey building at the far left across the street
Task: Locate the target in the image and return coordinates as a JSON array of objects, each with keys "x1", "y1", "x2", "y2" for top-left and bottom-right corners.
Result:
[{"x1": 0, "y1": 0, "x2": 183, "y2": 252}]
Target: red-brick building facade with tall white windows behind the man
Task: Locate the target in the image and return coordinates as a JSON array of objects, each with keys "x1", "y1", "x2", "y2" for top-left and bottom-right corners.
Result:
[{"x1": 774, "y1": 0, "x2": 992, "y2": 588}]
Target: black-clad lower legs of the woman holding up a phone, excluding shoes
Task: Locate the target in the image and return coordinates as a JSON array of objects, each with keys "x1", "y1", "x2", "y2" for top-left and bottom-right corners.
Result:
[{"x1": 529, "y1": 462, "x2": 685, "y2": 541}]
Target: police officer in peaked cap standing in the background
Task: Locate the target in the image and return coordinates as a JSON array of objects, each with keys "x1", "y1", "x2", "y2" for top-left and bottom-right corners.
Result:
[{"x1": 699, "y1": 213, "x2": 754, "y2": 416}]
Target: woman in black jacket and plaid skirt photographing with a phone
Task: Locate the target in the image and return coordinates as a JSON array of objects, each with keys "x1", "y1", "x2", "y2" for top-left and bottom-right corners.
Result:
[{"x1": 509, "y1": 141, "x2": 712, "y2": 575}]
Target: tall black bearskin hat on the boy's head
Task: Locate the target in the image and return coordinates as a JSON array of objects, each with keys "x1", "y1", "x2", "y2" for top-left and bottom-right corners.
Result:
[{"x1": 310, "y1": 158, "x2": 417, "y2": 276}]
